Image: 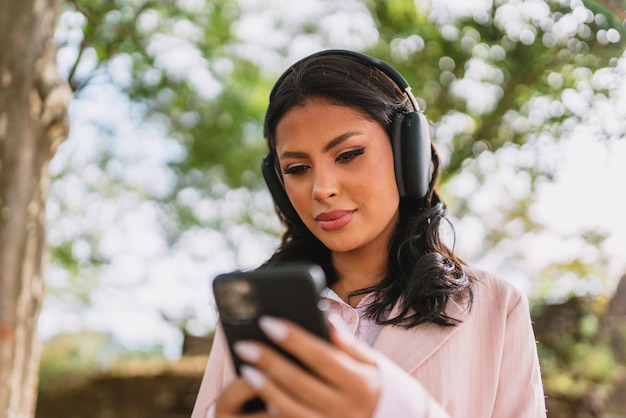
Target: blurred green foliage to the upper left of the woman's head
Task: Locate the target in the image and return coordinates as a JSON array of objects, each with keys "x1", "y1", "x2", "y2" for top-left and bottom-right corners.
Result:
[{"x1": 68, "y1": 0, "x2": 269, "y2": 187}]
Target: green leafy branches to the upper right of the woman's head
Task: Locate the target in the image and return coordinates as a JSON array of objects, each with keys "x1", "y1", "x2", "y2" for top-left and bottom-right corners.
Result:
[{"x1": 368, "y1": 0, "x2": 626, "y2": 183}]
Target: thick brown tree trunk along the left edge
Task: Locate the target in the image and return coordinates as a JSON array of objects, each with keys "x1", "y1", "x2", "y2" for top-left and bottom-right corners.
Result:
[{"x1": 0, "y1": 0, "x2": 71, "y2": 418}]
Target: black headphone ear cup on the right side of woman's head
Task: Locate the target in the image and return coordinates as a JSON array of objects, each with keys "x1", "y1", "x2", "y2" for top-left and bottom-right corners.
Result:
[{"x1": 394, "y1": 112, "x2": 432, "y2": 199}]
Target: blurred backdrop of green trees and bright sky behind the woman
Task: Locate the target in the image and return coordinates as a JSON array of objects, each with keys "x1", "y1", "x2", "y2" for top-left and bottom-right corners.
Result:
[{"x1": 22, "y1": 0, "x2": 626, "y2": 417}]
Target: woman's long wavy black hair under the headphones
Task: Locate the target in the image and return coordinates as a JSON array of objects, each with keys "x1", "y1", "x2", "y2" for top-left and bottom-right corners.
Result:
[{"x1": 264, "y1": 54, "x2": 472, "y2": 328}]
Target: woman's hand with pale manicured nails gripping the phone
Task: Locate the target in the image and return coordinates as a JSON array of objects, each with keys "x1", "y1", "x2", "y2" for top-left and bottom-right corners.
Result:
[{"x1": 228, "y1": 317, "x2": 380, "y2": 418}]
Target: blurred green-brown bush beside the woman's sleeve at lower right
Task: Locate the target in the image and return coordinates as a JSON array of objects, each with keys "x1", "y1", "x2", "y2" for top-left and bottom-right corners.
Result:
[{"x1": 532, "y1": 297, "x2": 626, "y2": 417}]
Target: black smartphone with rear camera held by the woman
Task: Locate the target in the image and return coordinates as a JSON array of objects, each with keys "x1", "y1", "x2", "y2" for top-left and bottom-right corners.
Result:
[{"x1": 213, "y1": 264, "x2": 329, "y2": 412}]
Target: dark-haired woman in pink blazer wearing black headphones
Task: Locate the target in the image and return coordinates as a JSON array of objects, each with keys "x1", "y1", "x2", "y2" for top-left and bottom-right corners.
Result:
[{"x1": 192, "y1": 50, "x2": 546, "y2": 418}]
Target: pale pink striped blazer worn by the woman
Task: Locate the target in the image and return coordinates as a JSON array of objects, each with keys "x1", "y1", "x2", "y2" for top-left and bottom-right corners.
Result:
[{"x1": 192, "y1": 271, "x2": 546, "y2": 418}]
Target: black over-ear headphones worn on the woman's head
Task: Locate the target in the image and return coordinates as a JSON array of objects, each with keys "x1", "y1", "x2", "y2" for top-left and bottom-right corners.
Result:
[{"x1": 262, "y1": 49, "x2": 431, "y2": 224}]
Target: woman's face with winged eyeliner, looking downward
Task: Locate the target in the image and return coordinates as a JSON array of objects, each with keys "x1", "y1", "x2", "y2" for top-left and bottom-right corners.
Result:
[{"x1": 275, "y1": 99, "x2": 400, "y2": 253}]
